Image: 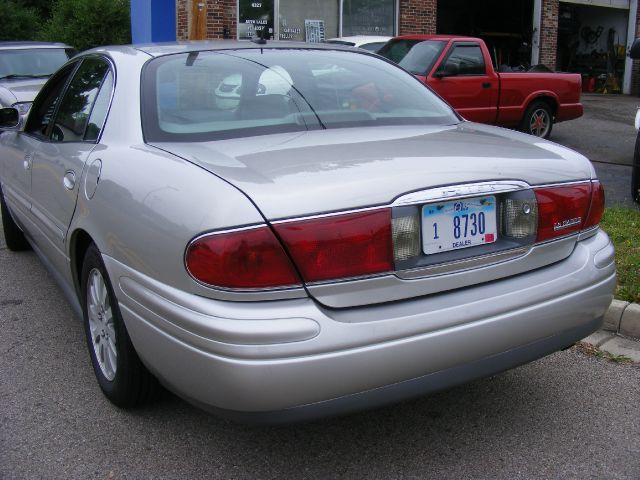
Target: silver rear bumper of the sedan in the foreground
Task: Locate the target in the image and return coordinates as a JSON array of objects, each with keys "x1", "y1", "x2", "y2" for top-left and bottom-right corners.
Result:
[{"x1": 105, "y1": 232, "x2": 616, "y2": 421}]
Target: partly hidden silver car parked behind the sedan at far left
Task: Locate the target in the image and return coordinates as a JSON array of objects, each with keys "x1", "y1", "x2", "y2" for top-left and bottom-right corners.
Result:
[{"x1": 0, "y1": 42, "x2": 75, "y2": 115}]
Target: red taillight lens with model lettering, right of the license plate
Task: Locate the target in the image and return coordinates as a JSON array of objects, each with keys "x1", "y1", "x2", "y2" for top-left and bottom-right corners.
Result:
[{"x1": 535, "y1": 182, "x2": 591, "y2": 242}]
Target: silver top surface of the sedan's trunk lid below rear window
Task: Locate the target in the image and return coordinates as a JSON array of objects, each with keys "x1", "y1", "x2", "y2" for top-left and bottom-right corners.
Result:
[{"x1": 154, "y1": 123, "x2": 592, "y2": 220}]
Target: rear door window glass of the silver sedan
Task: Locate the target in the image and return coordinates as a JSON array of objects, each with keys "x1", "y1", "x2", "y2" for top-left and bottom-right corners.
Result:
[{"x1": 51, "y1": 58, "x2": 109, "y2": 142}]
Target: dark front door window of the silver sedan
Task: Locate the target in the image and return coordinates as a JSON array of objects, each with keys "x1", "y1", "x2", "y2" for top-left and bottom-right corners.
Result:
[{"x1": 24, "y1": 62, "x2": 78, "y2": 139}]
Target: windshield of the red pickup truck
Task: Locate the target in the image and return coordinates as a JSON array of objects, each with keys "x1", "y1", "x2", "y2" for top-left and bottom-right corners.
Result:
[{"x1": 378, "y1": 39, "x2": 445, "y2": 75}]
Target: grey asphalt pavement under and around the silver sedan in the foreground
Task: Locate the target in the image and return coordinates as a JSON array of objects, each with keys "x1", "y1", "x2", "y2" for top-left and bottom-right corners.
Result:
[{"x1": 0, "y1": 247, "x2": 640, "y2": 480}]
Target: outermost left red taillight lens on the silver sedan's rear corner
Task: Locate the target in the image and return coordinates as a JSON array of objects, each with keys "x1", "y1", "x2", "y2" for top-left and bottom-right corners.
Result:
[{"x1": 186, "y1": 226, "x2": 301, "y2": 288}]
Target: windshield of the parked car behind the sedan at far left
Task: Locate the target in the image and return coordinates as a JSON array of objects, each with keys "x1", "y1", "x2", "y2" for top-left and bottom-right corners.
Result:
[{"x1": 0, "y1": 48, "x2": 70, "y2": 78}]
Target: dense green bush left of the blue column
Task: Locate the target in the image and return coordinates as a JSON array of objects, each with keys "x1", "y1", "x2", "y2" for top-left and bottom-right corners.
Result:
[{"x1": 38, "y1": 0, "x2": 131, "y2": 50}]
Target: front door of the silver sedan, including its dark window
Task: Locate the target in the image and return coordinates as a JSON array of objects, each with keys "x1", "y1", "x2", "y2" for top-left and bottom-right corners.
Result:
[{"x1": 0, "y1": 62, "x2": 78, "y2": 228}]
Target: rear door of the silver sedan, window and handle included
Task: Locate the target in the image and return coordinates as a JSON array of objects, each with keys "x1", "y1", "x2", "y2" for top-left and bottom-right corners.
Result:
[{"x1": 31, "y1": 56, "x2": 113, "y2": 267}]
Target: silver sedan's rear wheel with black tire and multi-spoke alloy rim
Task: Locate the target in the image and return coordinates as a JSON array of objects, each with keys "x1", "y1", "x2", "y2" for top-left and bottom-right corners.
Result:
[{"x1": 81, "y1": 244, "x2": 158, "y2": 408}]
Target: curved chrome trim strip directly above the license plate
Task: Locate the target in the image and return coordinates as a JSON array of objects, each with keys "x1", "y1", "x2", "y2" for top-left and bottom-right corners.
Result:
[{"x1": 391, "y1": 180, "x2": 532, "y2": 207}]
